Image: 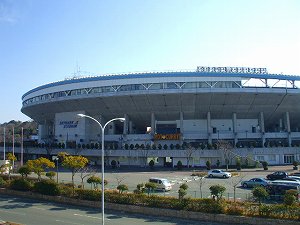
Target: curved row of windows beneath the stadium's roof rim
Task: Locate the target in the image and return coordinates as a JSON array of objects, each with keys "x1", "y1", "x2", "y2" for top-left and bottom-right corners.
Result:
[{"x1": 23, "y1": 81, "x2": 241, "y2": 106}]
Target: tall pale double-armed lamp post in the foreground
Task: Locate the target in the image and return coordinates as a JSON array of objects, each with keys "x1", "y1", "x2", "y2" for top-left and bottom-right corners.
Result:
[{"x1": 77, "y1": 113, "x2": 125, "y2": 225}]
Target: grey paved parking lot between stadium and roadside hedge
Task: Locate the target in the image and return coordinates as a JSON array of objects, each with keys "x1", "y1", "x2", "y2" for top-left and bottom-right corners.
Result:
[{"x1": 52, "y1": 165, "x2": 294, "y2": 200}]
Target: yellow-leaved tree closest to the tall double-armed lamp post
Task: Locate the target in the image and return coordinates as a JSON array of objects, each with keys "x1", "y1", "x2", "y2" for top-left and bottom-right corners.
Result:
[{"x1": 61, "y1": 154, "x2": 89, "y2": 185}]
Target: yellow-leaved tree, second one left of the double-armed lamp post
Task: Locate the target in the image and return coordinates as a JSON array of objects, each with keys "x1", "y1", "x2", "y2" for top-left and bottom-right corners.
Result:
[{"x1": 26, "y1": 157, "x2": 55, "y2": 181}]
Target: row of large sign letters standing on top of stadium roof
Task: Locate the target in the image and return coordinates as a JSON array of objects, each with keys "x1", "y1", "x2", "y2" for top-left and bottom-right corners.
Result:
[{"x1": 196, "y1": 66, "x2": 268, "y2": 74}]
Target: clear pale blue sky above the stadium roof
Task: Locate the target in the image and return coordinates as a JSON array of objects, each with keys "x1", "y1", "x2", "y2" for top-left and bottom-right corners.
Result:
[{"x1": 0, "y1": 0, "x2": 300, "y2": 123}]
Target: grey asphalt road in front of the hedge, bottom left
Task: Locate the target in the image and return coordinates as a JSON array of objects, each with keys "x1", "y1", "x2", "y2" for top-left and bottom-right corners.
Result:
[{"x1": 0, "y1": 196, "x2": 237, "y2": 225}]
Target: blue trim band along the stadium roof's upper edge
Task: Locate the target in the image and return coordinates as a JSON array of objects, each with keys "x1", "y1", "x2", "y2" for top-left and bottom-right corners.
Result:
[{"x1": 22, "y1": 72, "x2": 300, "y2": 99}]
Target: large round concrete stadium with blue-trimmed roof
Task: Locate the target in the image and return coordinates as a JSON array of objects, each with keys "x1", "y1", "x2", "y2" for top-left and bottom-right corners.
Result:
[{"x1": 21, "y1": 67, "x2": 300, "y2": 166}]
